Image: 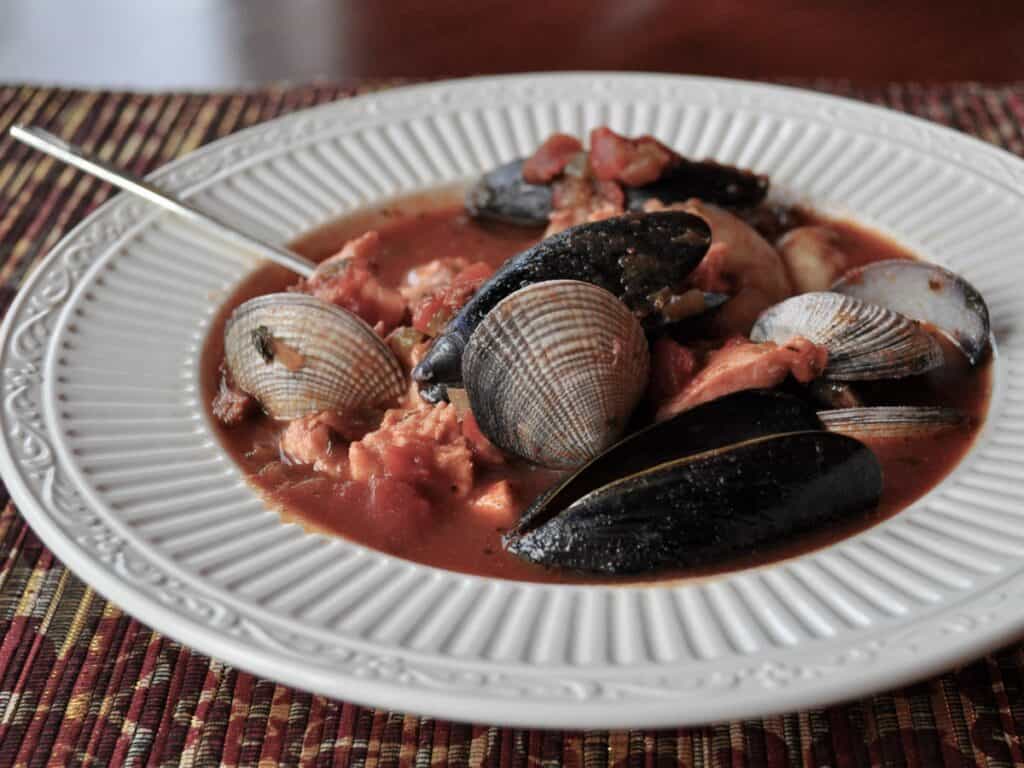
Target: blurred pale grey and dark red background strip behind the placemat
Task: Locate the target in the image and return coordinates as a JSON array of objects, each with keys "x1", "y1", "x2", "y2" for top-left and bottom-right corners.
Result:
[{"x1": 0, "y1": 0, "x2": 1024, "y2": 90}]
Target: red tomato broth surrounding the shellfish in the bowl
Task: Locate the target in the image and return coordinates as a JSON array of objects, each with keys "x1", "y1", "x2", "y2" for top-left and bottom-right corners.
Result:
[{"x1": 202, "y1": 193, "x2": 990, "y2": 583}]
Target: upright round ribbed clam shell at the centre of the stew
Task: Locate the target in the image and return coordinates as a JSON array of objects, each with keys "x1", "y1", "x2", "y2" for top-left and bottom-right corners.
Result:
[{"x1": 462, "y1": 281, "x2": 650, "y2": 468}]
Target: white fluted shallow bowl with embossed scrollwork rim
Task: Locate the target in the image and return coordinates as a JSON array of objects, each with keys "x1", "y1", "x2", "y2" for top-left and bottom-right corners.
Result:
[{"x1": 0, "y1": 74, "x2": 1024, "y2": 727}]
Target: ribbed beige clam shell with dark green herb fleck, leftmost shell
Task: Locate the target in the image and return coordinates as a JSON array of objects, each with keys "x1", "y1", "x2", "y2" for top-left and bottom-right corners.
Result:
[{"x1": 224, "y1": 293, "x2": 406, "y2": 419}]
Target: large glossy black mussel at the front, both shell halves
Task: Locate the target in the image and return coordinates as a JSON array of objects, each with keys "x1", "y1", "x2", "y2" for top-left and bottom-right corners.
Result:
[{"x1": 505, "y1": 390, "x2": 882, "y2": 573}]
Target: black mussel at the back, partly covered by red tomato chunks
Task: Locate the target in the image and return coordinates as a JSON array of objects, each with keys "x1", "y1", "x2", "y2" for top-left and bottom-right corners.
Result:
[{"x1": 466, "y1": 158, "x2": 768, "y2": 226}]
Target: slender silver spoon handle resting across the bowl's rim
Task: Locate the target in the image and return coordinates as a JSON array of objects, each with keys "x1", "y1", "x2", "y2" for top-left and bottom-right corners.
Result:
[{"x1": 10, "y1": 125, "x2": 316, "y2": 278}]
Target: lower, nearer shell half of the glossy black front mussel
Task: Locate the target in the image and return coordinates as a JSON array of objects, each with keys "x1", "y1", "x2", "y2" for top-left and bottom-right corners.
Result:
[{"x1": 506, "y1": 431, "x2": 882, "y2": 574}]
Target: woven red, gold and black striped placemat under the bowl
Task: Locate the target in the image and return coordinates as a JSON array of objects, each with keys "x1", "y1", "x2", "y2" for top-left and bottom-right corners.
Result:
[{"x1": 0, "y1": 83, "x2": 1024, "y2": 768}]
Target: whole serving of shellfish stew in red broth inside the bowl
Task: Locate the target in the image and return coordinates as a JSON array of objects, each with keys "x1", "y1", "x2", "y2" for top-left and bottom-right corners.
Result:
[{"x1": 204, "y1": 128, "x2": 990, "y2": 582}]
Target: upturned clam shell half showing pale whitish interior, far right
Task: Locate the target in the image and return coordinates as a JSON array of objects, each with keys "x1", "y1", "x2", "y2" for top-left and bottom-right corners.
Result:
[{"x1": 831, "y1": 259, "x2": 990, "y2": 366}]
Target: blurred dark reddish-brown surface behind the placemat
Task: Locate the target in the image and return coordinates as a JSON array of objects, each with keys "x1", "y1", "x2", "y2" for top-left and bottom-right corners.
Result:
[{"x1": 339, "y1": 0, "x2": 1024, "y2": 85}]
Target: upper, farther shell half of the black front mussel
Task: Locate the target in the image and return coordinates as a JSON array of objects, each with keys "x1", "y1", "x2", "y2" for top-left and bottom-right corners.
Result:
[{"x1": 506, "y1": 389, "x2": 821, "y2": 540}]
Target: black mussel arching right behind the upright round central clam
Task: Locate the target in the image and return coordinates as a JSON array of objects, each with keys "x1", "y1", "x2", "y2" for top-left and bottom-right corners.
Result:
[{"x1": 413, "y1": 211, "x2": 711, "y2": 393}]
